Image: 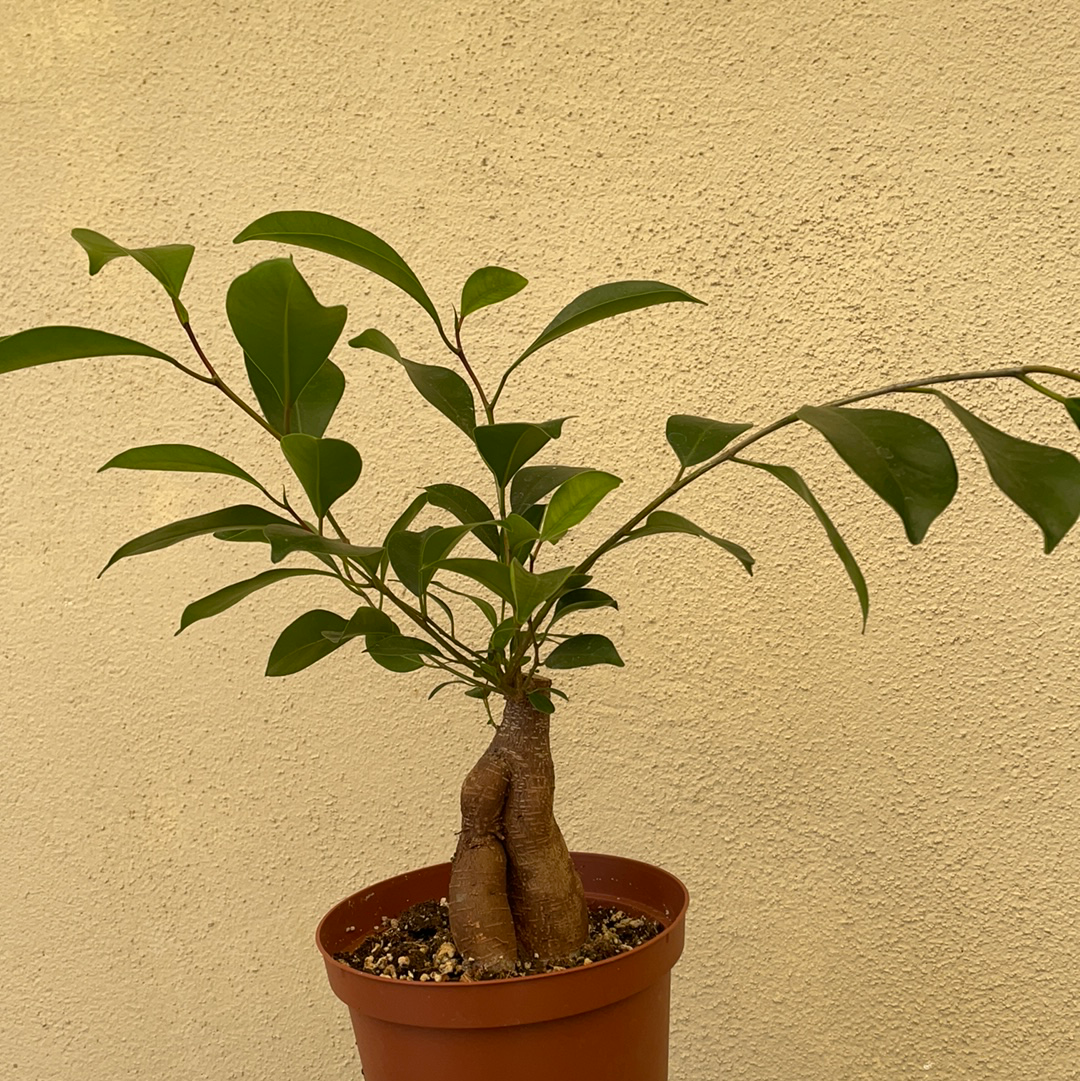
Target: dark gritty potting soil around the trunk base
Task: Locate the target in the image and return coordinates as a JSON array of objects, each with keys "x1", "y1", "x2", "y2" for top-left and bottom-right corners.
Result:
[{"x1": 334, "y1": 900, "x2": 663, "y2": 984}]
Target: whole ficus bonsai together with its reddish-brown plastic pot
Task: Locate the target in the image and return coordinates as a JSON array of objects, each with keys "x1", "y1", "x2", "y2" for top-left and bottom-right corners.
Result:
[{"x1": 0, "y1": 212, "x2": 1080, "y2": 1081}]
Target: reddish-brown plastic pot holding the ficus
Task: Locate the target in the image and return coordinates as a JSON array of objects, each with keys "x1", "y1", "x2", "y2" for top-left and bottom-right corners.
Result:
[{"x1": 316, "y1": 852, "x2": 690, "y2": 1081}]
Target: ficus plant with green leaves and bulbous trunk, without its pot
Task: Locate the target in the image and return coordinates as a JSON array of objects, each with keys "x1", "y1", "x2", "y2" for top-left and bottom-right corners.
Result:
[{"x1": 6, "y1": 212, "x2": 1080, "y2": 976}]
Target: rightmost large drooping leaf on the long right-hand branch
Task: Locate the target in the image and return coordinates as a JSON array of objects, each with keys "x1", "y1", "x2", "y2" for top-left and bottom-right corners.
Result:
[{"x1": 933, "y1": 390, "x2": 1080, "y2": 555}]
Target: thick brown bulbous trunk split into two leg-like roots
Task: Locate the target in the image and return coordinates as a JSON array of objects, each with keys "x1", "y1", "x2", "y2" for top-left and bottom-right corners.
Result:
[{"x1": 449, "y1": 696, "x2": 589, "y2": 976}]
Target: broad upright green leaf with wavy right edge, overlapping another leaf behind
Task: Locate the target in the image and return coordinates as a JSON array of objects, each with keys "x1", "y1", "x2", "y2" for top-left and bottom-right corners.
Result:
[{"x1": 225, "y1": 259, "x2": 346, "y2": 435}]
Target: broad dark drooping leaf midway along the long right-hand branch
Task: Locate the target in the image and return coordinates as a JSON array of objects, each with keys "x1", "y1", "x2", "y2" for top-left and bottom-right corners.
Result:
[{"x1": 796, "y1": 405, "x2": 957, "y2": 544}]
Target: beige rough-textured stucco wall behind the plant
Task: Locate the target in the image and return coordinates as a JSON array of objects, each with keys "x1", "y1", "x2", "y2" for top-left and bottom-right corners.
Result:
[{"x1": 0, "y1": 0, "x2": 1080, "y2": 1081}]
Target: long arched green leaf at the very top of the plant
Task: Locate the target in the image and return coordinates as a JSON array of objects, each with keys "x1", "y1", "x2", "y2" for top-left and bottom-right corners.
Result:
[{"x1": 232, "y1": 211, "x2": 442, "y2": 330}]
